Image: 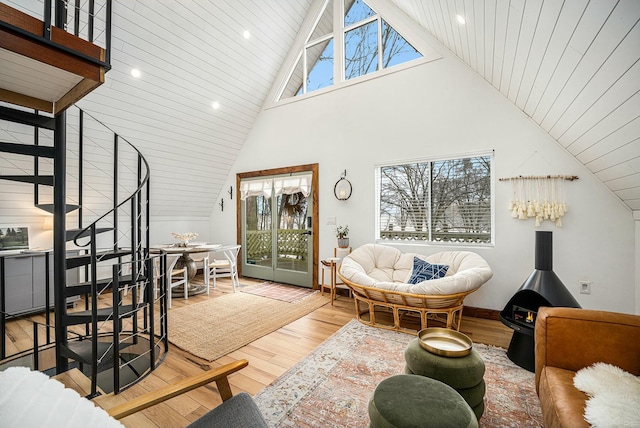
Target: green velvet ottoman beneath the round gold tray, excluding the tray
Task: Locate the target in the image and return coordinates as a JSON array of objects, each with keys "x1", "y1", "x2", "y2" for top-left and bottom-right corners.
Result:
[{"x1": 404, "y1": 339, "x2": 486, "y2": 419}]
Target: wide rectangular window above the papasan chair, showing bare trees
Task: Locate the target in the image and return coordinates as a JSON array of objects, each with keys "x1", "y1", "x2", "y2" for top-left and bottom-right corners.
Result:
[{"x1": 376, "y1": 154, "x2": 493, "y2": 244}]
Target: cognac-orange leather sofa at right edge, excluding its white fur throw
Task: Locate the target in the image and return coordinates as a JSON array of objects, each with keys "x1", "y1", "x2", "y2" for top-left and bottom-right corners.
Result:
[{"x1": 535, "y1": 307, "x2": 640, "y2": 428}]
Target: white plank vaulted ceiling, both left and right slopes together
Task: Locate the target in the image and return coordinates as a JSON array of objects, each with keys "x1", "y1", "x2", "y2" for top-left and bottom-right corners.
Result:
[{"x1": 5, "y1": 0, "x2": 640, "y2": 217}]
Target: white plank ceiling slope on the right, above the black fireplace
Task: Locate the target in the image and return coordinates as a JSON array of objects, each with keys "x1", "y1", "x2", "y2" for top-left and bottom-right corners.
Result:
[{"x1": 392, "y1": 0, "x2": 640, "y2": 210}]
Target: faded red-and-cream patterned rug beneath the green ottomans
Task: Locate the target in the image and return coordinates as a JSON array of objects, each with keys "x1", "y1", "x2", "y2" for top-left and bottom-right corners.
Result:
[{"x1": 254, "y1": 320, "x2": 542, "y2": 428}]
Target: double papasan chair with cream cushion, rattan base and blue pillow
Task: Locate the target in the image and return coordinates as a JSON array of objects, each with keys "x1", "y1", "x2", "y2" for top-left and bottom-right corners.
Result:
[{"x1": 338, "y1": 244, "x2": 493, "y2": 331}]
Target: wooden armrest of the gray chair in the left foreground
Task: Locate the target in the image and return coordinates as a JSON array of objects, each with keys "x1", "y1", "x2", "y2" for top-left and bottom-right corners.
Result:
[{"x1": 107, "y1": 359, "x2": 249, "y2": 419}]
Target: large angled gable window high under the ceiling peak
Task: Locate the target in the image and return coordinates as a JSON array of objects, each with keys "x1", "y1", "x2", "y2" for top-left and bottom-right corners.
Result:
[{"x1": 279, "y1": 0, "x2": 422, "y2": 100}]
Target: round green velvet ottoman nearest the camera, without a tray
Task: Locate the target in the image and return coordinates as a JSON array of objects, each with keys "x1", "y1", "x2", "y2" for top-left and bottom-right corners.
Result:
[{"x1": 369, "y1": 374, "x2": 478, "y2": 428}]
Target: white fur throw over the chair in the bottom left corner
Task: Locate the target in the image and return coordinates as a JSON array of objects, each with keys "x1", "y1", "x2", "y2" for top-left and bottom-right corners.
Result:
[{"x1": 0, "y1": 367, "x2": 123, "y2": 428}]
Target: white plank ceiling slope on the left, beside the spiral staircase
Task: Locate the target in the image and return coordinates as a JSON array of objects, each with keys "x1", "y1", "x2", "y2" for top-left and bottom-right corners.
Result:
[{"x1": 79, "y1": 0, "x2": 311, "y2": 217}]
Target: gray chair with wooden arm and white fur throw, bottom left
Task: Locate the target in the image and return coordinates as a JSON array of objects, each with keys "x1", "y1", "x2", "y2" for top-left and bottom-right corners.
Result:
[{"x1": 0, "y1": 360, "x2": 267, "y2": 428}]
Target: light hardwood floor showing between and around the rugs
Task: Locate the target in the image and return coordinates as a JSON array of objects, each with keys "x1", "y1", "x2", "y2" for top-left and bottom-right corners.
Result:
[{"x1": 0, "y1": 275, "x2": 512, "y2": 427}]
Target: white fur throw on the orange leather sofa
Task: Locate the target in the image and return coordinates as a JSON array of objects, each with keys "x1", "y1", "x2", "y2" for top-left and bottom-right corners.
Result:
[{"x1": 573, "y1": 363, "x2": 640, "y2": 428}]
